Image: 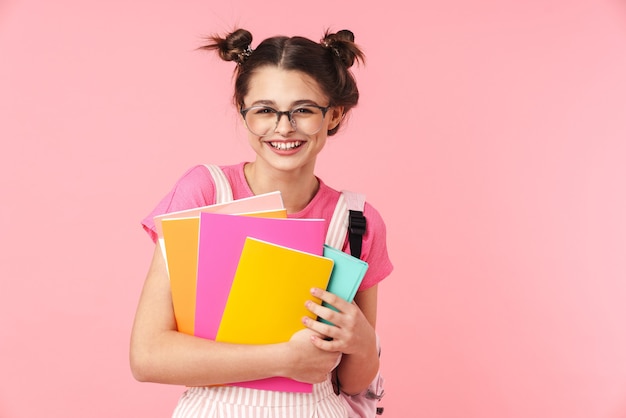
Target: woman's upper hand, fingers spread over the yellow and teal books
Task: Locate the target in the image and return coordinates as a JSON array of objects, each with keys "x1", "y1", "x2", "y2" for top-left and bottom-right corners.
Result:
[{"x1": 302, "y1": 288, "x2": 376, "y2": 354}]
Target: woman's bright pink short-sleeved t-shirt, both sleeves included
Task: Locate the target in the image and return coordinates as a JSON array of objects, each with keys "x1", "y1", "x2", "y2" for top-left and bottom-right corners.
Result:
[{"x1": 142, "y1": 162, "x2": 393, "y2": 290}]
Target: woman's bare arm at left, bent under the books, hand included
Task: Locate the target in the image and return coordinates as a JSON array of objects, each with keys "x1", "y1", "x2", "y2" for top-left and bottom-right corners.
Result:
[{"x1": 130, "y1": 245, "x2": 338, "y2": 386}]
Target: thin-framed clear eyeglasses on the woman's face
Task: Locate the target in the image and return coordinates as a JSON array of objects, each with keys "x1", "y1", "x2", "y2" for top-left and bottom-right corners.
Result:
[{"x1": 240, "y1": 104, "x2": 331, "y2": 136}]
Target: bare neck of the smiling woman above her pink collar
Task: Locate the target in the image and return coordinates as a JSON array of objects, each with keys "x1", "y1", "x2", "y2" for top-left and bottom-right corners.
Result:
[{"x1": 244, "y1": 163, "x2": 319, "y2": 213}]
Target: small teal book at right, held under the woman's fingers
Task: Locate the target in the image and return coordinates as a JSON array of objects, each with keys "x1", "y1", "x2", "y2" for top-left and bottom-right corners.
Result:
[{"x1": 320, "y1": 244, "x2": 368, "y2": 325}]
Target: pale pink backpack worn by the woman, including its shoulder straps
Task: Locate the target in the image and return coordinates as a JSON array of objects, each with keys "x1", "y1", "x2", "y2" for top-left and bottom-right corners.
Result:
[{"x1": 206, "y1": 165, "x2": 385, "y2": 418}]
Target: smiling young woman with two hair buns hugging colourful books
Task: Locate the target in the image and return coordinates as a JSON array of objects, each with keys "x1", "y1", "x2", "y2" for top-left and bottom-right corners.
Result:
[{"x1": 130, "y1": 29, "x2": 392, "y2": 418}]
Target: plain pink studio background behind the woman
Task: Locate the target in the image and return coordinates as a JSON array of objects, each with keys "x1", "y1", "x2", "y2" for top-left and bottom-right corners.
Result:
[{"x1": 0, "y1": 0, "x2": 626, "y2": 418}]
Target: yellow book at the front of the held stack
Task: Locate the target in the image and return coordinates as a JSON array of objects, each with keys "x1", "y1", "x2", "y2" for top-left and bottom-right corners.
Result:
[{"x1": 216, "y1": 237, "x2": 333, "y2": 344}]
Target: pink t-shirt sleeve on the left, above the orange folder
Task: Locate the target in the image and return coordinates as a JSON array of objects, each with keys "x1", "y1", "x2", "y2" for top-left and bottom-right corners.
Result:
[{"x1": 141, "y1": 165, "x2": 215, "y2": 242}]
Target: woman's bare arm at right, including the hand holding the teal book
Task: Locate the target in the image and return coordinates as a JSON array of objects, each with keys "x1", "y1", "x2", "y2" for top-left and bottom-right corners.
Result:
[{"x1": 304, "y1": 285, "x2": 379, "y2": 394}]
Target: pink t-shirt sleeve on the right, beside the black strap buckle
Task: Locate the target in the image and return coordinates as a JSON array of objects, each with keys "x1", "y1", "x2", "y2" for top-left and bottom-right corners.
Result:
[{"x1": 359, "y1": 203, "x2": 393, "y2": 291}]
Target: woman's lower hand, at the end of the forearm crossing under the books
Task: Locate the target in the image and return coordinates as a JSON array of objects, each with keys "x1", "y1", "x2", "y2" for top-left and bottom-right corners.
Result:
[{"x1": 285, "y1": 328, "x2": 341, "y2": 383}]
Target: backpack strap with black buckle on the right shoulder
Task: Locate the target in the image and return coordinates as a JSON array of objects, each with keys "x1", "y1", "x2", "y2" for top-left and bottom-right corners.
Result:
[{"x1": 326, "y1": 190, "x2": 367, "y2": 258}]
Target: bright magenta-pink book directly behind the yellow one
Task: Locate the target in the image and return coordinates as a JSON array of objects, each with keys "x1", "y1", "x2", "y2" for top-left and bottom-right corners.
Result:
[{"x1": 194, "y1": 213, "x2": 326, "y2": 392}]
